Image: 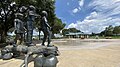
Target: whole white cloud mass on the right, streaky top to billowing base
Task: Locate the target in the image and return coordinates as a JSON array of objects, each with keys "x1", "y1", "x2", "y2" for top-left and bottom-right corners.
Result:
[{"x1": 68, "y1": 0, "x2": 120, "y2": 33}]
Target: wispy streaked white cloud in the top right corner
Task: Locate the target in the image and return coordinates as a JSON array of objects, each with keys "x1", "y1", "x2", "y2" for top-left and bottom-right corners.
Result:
[{"x1": 89, "y1": 0, "x2": 120, "y2": 16}]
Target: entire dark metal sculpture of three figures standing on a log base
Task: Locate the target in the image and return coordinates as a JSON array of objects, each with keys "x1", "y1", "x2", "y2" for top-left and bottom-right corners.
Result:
[{"x1": 0, "y1": 5, "x2": 59, "y2": 67}]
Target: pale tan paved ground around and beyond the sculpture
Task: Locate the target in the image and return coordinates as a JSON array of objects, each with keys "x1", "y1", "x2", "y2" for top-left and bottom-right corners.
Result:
[{"x1": 0, "y1": 39, "x2": 120, "y2": 67}]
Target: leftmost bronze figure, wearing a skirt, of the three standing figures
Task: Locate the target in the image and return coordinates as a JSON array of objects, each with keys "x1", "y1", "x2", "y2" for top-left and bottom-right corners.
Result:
[{"x1": 14, "y1": 13, "x2": 25, "y2": 45}]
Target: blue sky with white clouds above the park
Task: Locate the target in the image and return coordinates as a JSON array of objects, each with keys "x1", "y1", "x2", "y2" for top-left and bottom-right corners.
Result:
[{"x1": 55, "y1": 0, "x2": 120, "y2": 33}]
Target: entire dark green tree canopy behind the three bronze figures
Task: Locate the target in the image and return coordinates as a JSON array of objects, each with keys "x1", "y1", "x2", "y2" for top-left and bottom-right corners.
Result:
[{"x1": 0, "y1": 0, "x2": 65, "y2": 41}]
